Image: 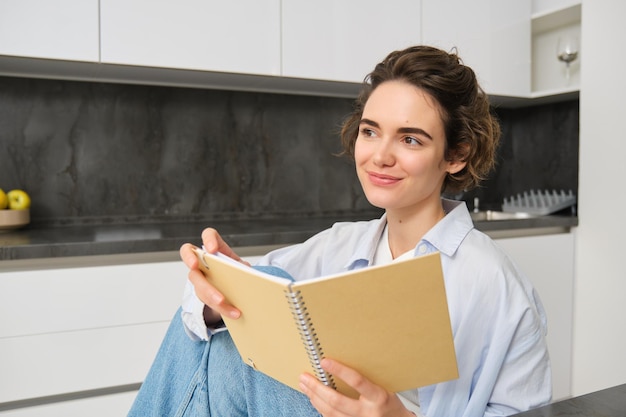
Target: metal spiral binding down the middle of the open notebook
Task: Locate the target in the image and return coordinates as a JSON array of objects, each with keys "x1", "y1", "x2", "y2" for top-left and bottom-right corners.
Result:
[{"x1": 285, "y1": 291, "x2": 336, "y2": 388}]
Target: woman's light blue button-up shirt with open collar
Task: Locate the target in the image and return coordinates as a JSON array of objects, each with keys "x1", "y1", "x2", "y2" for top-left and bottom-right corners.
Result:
[{"x1": 183, "y1": 200, "x2": 552, "y2": 417}]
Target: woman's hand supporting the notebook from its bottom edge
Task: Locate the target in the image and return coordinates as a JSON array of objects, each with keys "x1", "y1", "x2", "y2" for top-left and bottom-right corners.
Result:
[{"x1": 300, "y1": 359, "x2": 415, "y2": 417}]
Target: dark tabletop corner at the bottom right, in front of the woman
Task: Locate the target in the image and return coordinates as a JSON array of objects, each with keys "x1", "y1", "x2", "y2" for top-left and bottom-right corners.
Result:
[{"x1": 515, "y1": 384, "x2": 626, "y2": 417}]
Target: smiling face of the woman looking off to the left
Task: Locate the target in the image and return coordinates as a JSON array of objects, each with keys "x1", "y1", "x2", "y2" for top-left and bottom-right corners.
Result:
[{"x1": 354, "y1": 81, "x2": 464, "y2": 212}]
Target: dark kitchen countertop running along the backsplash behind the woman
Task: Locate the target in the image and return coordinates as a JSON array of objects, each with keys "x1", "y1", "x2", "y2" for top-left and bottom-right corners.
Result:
[{"x1": 0, "y1": 213, "x2": 578, "y2": 261}]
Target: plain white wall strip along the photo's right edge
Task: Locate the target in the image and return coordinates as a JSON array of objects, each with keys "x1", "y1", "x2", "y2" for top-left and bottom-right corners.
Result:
[{"x1": 572, "y1": 0, "x2": 626, "y2": 395}]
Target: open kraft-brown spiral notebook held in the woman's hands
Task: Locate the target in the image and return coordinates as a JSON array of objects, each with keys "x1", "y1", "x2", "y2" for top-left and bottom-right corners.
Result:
[{"x1": 198, "y1": 249, "x2": 458, "y2": 397}]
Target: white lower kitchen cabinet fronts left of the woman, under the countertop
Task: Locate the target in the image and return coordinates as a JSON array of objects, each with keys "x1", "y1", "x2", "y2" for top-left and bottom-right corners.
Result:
[{"x1": 0, "y1": 257, "x2": 187, "y2": 416}]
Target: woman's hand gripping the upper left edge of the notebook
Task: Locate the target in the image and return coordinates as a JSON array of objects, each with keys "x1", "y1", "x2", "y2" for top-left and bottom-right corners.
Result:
[{"x1": 180, "y1": 228, "x2": 249, "y2": 325}]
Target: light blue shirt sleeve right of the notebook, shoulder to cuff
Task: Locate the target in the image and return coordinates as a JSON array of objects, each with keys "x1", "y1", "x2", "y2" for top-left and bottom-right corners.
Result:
[{"x1": 419, "y1": 234, "x2": 552, "y2": 417}]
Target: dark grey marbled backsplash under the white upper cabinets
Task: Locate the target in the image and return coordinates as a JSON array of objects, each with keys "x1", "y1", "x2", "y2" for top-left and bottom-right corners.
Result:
[{"x1": 0, "y1": 77, "x2": 578, "y2": 221}]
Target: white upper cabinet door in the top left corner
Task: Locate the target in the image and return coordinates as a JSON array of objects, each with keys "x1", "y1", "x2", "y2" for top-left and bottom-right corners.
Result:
[{"x1": 0, "y1": 0, "x2": 99, "y2": 62}]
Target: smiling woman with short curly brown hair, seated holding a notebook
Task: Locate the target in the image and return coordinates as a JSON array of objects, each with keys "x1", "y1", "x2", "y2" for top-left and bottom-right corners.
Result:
[{"x1": 131, "y1": 46, "x2": 551, "y2": 417}]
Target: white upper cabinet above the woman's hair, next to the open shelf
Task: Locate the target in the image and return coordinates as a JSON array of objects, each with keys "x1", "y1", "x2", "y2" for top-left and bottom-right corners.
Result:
[{"x1": 422, "y1": 0, "x2": 531, "y2": 97}]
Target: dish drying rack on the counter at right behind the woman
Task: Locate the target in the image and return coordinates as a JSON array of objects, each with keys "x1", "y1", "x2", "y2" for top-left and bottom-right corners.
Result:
[{"x1": 502, "y1": 190, "x2": 576, "y2": 216}]
